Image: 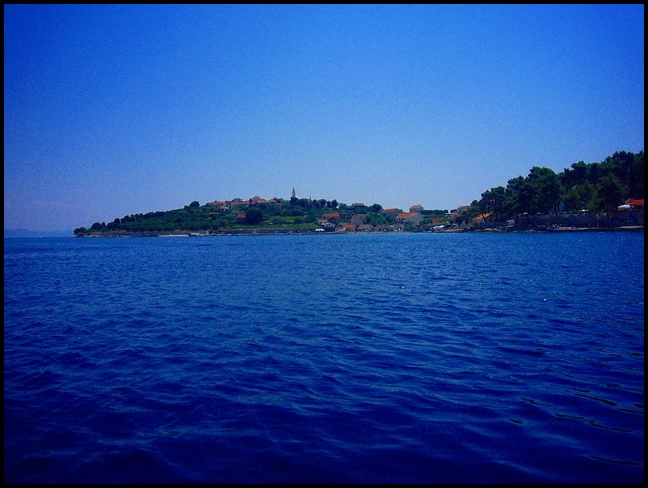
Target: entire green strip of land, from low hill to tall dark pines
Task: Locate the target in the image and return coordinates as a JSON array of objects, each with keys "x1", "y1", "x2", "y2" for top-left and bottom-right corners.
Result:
[{"x1": 74, "y1": 151, "x2": 644, "y2": 237}]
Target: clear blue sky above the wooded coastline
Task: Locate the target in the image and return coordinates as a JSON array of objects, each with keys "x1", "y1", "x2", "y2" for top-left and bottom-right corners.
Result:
[{"x1": 4, "y1": 5, "x2": 644, "y2": 231}]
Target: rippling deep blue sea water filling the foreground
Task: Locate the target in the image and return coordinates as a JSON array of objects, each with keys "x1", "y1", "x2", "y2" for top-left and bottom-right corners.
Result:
[{"x1": 4, "y1": 232, "x2": 644, "y2": 483}]
